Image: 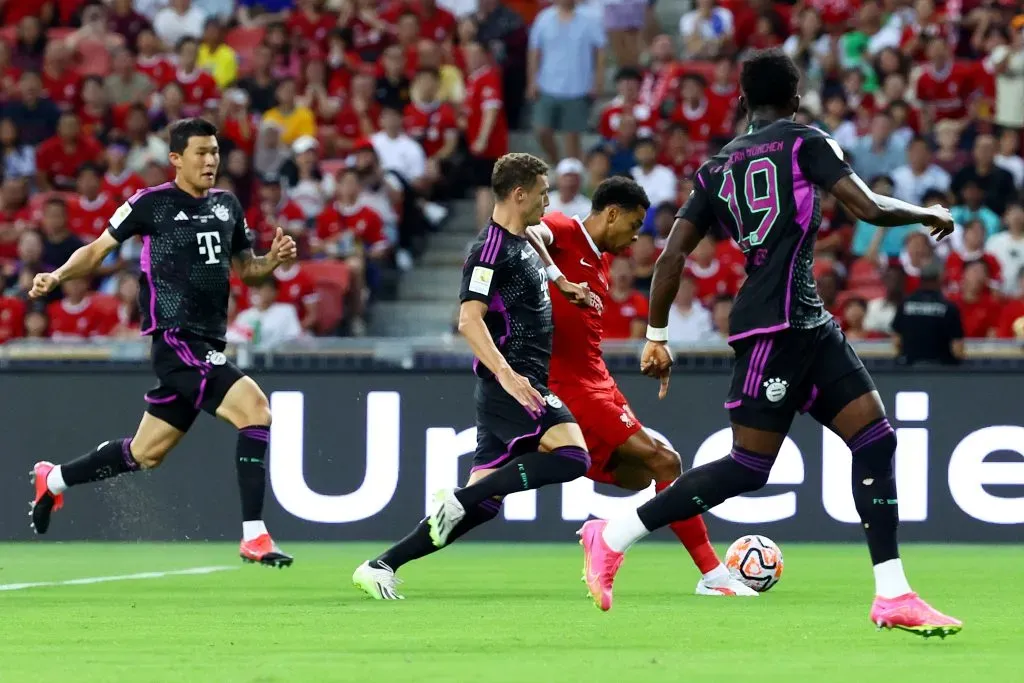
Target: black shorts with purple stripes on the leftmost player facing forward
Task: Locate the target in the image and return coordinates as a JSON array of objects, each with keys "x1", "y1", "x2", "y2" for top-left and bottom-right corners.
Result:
[{"x1": 145, "y1": 329, "x2": 246, "y2": 431}]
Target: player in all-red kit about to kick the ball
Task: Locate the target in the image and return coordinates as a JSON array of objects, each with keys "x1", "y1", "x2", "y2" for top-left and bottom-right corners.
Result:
[{"x1": 527, "y1": 183, "x2": 757, "y2": 596}]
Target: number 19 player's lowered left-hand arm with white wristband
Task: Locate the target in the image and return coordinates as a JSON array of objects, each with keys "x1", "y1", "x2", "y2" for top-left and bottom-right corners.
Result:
[{"x1": 640, "y1": 218, "x2": 708, "y2": 398}]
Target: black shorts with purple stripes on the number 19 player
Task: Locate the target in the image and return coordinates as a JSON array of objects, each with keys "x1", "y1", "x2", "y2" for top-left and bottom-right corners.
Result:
[{"x1": 725, "y1": 321, "x2": 874, "y2": 434}]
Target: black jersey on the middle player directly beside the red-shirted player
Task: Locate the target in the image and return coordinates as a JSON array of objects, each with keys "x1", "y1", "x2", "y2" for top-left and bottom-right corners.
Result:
[{"x1": 459, "y1": 222, "x2": 553, "y2": 384}]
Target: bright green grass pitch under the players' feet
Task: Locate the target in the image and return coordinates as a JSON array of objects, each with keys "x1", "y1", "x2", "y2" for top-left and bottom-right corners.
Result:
[{"x1": 0, "y1": 542, "x2": 1024, "y2": 683}]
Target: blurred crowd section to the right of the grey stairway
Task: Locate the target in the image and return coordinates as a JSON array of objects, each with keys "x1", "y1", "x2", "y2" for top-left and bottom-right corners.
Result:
[{"x1": 527, "y1": 0, "x2": 1024, "y2": 342}]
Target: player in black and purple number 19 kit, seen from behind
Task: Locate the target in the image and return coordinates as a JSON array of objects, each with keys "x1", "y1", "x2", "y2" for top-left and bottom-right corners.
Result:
[{"x1": 581, "y1": 50, "x2": 962, "y2": 637}]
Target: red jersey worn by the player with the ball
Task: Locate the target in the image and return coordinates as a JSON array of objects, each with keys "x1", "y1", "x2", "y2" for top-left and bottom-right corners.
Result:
[{"x1": 541, "y1": 212, "x2": 615, "y2": 389}]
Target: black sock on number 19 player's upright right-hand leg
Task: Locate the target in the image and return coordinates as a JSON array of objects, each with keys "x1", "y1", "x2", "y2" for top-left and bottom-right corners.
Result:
[{"x1": 850, "y1": 418, "x2": 899, "y2": 564}]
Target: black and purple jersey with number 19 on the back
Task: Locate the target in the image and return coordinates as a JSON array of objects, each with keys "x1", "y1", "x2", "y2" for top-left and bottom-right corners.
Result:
[{"x1": 678, "y1": 119, "x2": 853, "y2": 341}]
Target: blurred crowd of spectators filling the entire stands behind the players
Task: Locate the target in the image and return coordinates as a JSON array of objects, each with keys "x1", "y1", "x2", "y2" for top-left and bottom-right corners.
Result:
[{"x1": 0, "y1": 0, "x2": 1024, "y2": 352}]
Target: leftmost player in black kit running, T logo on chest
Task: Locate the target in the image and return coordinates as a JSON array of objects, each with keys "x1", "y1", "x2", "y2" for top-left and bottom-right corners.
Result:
[{"x1": 30, "y1": 119, "x2": 297, "y2": 566}]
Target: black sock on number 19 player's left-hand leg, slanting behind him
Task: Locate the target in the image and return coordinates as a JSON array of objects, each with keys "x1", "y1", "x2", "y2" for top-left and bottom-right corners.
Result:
[{"x1": 637, "y1": 446, "x2": 775, "y2": 531}]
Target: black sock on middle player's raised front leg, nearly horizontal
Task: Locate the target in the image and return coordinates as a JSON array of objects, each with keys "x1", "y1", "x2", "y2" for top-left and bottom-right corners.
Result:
[{"x1": 455, "y1": 445, "x2": 590, "y2": 510}]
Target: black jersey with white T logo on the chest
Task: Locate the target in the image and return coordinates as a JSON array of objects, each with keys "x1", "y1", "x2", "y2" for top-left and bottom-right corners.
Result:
[{"x1": 106, "y1": 182, "x2": 252, "y2": 340}]
